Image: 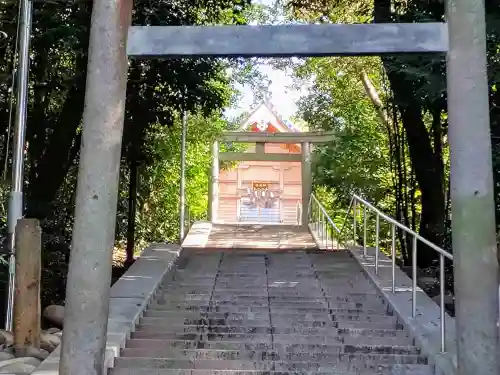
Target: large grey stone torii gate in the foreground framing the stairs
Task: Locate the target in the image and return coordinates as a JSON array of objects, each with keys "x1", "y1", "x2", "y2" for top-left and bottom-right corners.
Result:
[{"x1": 60, "y1": 0, "x2": 500, "y2": 375}]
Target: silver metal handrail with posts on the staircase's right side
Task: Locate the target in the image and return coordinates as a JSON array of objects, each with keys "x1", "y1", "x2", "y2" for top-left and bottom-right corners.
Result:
[{"x1": 311, "y1": 194, "x2": 453, "y2": 352}]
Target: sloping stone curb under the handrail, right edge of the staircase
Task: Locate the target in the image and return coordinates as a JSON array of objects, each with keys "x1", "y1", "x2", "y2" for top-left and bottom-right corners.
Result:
[{"x1": 349, "y1": 248, "x2": 457, "y2": 375}]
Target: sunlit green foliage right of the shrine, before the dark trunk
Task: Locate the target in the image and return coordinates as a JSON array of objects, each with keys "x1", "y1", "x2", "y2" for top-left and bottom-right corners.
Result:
[{"x1": 296, "y1": 58, "x2": 391, "y2": 204}]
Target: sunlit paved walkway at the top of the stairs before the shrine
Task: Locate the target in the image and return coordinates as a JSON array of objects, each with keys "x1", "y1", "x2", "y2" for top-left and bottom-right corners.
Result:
[{"x1": 206, "y1": 224, "x2": 316, "y2": 250}]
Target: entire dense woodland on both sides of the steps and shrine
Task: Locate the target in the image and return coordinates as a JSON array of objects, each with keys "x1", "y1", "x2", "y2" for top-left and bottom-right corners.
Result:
[{"x1": 0, "y1": 0, "x2": 500, "y2": 321}]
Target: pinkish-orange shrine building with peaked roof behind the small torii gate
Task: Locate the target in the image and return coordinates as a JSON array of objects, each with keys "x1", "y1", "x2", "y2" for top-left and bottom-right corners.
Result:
[{"x1": 216, "y1": 101, "x2": 302, "y2": 225}]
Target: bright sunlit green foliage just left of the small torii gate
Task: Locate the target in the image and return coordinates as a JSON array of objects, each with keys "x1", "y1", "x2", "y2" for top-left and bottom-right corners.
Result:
[{"x1": 136, "y1": 114, "x2": 227, "y2": 243}]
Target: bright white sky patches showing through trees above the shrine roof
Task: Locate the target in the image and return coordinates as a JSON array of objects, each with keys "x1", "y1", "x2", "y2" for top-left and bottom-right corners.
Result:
[{"x1": 226, "y1": 0, "x2": 306, "y2": 120}]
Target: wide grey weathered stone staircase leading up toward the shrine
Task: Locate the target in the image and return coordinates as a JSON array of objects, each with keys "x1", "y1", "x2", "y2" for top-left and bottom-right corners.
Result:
[{"x1": 109, "y1": 250, "x2": 434, "y2": 375}]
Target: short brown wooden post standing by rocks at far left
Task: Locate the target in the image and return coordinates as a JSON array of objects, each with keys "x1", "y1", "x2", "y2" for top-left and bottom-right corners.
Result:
[{"x1": 14, "y1": 219, "x2": 42, "y2": 353}]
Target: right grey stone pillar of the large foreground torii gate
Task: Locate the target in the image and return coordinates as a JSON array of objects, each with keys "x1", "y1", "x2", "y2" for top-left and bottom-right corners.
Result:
[{"x1": 447, "y1": 0, "x2": 500, "y2": 375}]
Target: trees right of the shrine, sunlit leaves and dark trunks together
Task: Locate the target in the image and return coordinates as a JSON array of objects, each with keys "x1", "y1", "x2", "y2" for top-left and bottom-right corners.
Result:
[{"x1": 281, "y1": 0, "x2": 500, "y2": 268}]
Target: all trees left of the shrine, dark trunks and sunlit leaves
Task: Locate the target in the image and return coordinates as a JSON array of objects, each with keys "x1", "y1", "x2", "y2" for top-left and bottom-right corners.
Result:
[{"x1": 0, "y1": 0, "x2": 254, "y2": 319}]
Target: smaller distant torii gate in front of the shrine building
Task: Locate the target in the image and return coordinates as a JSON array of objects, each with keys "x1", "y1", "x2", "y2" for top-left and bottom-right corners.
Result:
[{"x1": 208, "y1": 132, "x2": 334, "y2": 226}]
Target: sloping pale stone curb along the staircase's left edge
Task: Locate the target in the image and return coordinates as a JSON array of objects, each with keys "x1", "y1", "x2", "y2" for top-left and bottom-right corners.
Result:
[{"x1": 32, "y1": 244, "x2": 181, "y2": 375}]
